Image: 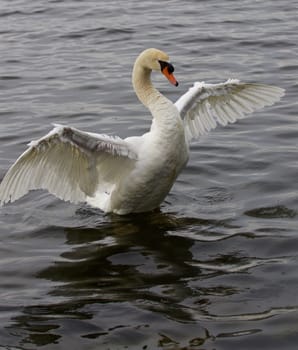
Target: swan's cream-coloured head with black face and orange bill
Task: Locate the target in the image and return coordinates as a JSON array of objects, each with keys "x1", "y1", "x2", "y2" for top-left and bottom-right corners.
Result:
[{"x1": 137, "y1": 49, "x2": 178, "y2": 86}]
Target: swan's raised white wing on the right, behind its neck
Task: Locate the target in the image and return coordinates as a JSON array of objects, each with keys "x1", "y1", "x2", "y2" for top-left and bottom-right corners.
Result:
[{"x1": 175, "y1": 79, "x2": 284, "y2": 141}]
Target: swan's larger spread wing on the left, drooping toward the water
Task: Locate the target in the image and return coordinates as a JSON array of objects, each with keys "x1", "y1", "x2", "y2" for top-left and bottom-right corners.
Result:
[{"x1": 0, "y1": 125, "x2": 137, "y2": 205}]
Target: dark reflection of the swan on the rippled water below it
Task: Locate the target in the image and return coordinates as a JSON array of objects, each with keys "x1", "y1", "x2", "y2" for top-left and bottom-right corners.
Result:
[{"x1": 8, "y1": 212, "x2": 220, "y2": 345}]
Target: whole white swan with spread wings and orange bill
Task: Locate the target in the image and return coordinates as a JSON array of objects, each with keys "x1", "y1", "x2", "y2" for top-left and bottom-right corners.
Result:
[{"x1": 0, "y1": 49, "x2": 284, "y2": 214}]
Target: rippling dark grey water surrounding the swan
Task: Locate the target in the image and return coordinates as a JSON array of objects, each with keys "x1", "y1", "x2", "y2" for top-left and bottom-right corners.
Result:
[{"x1": 0, "y1": 0, "x2": 298, "y2": 350}]
